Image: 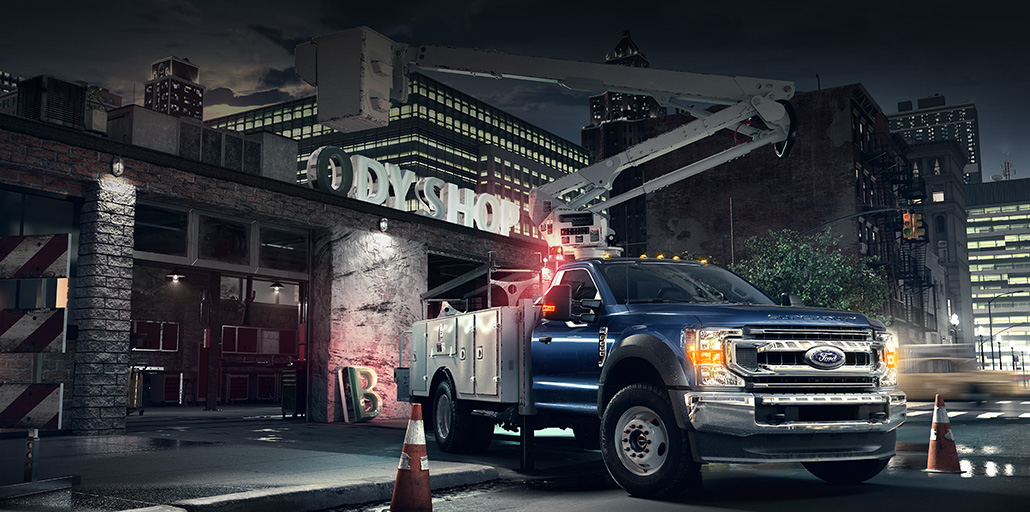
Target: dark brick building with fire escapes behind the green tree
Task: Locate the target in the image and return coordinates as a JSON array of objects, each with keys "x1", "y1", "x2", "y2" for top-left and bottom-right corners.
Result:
[{"x1": 642, "y1": 84, "x2": 943, "y2": 343}]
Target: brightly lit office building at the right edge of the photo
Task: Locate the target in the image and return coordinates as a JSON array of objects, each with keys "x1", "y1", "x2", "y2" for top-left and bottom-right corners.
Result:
[{"x1": 966, "y1": 175, "x2": 1030, "y2": 370}]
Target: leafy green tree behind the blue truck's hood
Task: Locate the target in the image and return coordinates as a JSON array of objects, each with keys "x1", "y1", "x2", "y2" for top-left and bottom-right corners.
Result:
[{"x1": 730, "y1": 230, "x2": 889, "y2": 322}]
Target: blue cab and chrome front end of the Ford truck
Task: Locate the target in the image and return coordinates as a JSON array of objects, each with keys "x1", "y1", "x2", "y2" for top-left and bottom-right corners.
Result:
[{"x1": 531, "y1": 259, "x2": 905, "y2": 488}]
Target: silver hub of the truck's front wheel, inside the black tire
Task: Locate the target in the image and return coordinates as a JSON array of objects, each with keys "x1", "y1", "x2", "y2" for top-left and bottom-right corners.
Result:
[{"x1": 616, "y1": 406, "x2": 668, "y2": 476}]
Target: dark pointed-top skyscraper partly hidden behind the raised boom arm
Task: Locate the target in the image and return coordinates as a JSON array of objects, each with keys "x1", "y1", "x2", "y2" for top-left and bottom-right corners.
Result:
[{"x1": 581, "y1": 30, "x2": 666, "y2": 254}]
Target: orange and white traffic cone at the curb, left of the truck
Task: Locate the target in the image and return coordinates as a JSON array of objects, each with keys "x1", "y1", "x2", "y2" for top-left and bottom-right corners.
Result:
[{"x1": 389, "y1": 404, "x2": 433, "y2": 512}]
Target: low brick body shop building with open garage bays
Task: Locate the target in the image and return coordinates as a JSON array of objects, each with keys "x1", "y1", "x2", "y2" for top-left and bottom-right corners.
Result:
[{"x1": 0, "y1": 112, "x2": 544, "y2": 435}]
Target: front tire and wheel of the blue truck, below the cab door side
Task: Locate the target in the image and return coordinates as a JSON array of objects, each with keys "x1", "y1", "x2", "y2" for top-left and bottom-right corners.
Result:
[{"x1": 600, "y1": 384, "x2": 700, "y2": 498}]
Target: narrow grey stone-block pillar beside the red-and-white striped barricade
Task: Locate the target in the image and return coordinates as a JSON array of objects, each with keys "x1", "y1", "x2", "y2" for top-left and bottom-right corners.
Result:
[{"x1": 68, "y1": 176, "x2": 136, "y2": 436}]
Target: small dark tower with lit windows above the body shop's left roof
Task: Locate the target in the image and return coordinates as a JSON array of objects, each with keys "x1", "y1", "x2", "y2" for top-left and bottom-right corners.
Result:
[{"x1": 143, "y1": 57, "x2": 204, "y2": 120}]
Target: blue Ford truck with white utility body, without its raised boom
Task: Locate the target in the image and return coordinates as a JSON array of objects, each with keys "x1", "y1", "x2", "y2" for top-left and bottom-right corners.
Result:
[{"x1": 399, "y1": 259, "x2": 905, "y2": 498}]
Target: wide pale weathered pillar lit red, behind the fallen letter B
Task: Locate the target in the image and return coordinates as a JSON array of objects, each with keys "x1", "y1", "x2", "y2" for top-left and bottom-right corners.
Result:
[{"x1": 308, "y1": 228, "x2": 428, "y2": 421}]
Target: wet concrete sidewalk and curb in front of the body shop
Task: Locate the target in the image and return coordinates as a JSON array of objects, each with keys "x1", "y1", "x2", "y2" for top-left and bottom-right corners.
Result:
[{"x1": 0, "y1": 406, "x2": 497, "y2": 512}]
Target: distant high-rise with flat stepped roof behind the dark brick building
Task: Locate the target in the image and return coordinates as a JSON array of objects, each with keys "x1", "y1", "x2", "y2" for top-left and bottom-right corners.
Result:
[{"x1": 887, "y1": 95, "x2": 983, "y2": 183}]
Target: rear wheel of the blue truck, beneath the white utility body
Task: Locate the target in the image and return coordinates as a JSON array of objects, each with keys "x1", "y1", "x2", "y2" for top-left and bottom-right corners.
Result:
[{"x1": 433, "y1": 380, "x2": 493, "y2": 453}]
